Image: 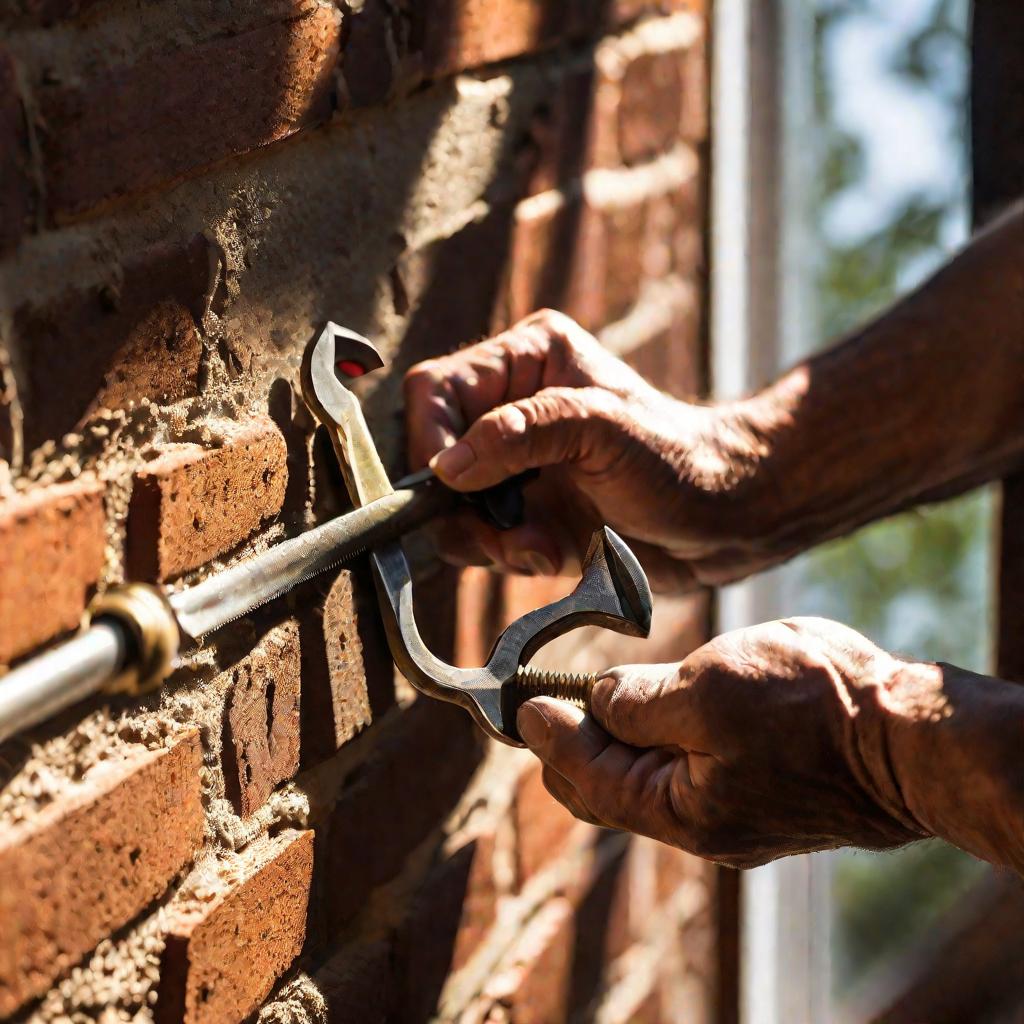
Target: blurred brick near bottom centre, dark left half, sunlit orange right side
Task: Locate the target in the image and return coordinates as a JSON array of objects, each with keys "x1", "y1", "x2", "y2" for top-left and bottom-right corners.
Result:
[{"x1": 395, "y1": 836, "x2": 498, "y2": 1021}]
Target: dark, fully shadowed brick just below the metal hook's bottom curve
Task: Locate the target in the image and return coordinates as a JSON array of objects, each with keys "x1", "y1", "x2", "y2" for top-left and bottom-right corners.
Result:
[{"x1": 326, "y1": 698, "x2": 483, "y2": 931}]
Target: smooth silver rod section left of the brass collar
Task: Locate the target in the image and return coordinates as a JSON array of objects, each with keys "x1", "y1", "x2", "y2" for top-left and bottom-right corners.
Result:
[{"x1": 0, "y1": 621, "x2": 128, "y2": 742}]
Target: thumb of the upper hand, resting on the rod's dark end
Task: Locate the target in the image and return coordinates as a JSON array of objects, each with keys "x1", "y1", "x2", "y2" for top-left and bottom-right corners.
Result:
[{"x1": 430, "y1": 387, "x2": 608, "y2": 490}]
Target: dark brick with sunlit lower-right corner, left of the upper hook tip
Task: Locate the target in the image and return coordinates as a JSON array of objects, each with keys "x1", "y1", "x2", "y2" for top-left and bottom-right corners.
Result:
[{"x1": 14, "y1": 236, "x2": 218, "y2": 449}]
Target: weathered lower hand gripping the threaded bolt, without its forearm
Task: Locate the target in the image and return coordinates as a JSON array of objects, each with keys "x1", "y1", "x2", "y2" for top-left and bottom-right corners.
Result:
[{"x1": 518, "y1": 618, "x2": 927, "y2": 867}]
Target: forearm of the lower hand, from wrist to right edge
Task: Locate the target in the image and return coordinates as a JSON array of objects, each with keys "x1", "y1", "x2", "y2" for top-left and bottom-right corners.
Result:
[{"x1": 859, "y1": 665, "x2": 1024, "y2": 873}]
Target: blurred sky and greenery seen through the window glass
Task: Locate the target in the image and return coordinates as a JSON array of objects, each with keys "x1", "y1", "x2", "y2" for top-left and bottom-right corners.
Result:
[{"x1": 784, "y1": 0, "x2": 992, "y2": 1019}]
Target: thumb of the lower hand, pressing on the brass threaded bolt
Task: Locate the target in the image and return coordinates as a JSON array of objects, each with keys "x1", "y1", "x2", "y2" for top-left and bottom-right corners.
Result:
[{"x1": 591, "y1": 664, "x2": 699, "y2": 750}]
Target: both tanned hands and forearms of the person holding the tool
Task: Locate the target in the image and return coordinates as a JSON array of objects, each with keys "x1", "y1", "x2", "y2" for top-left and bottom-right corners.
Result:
[{"x1": 406, "y1": 204, "x2": 1024, "y2": 872}]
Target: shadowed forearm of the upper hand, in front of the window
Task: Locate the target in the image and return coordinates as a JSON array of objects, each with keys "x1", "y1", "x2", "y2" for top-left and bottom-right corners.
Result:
[{"x1": 745, "y1": 204, "x2": 1024, "y2": 554}]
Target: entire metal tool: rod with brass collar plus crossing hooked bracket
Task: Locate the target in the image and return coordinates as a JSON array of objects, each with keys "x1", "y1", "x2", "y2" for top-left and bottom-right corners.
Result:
[{"x1": 0, "y1": 324, "x2": 651, "y2": 742}]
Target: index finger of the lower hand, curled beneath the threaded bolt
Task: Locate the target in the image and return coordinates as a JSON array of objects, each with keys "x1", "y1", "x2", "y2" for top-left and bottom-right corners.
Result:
[{"x1": 517, "y1": 697, "x2": 678, "y2": 838}]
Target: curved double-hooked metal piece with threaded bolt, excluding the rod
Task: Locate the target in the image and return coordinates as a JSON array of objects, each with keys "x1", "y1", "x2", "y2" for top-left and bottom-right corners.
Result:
[{"x1": 302, "y1": 324, "x2": 652, "y2": 745}]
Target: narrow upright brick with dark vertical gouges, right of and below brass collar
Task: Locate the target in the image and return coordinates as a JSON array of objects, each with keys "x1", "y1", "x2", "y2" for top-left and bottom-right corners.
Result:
[{"x1": 222, "y1": 621, "x2": 301, "y2": 817}]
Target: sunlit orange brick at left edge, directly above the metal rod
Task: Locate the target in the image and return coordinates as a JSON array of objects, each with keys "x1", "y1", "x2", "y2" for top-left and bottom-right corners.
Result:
[{"x1": 0, "y1": 477, "x2": 106, "y2": 663}]
